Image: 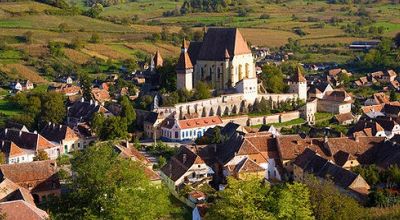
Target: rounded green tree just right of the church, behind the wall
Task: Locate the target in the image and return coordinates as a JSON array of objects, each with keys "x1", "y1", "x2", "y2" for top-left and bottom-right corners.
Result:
[{"x1": 260, "y1": 65, "x2": 287, "y2": 93}]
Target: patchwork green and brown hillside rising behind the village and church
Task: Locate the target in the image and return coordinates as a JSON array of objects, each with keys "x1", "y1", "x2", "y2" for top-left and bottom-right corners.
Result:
[{"x1": 0, "y1": 0, "x2": 400, "y2": 82}]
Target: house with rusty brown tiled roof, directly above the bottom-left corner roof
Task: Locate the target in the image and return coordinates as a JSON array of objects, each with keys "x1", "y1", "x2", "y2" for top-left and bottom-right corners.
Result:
[{"x1": 0, "y1": 160, "x2": 61, "y2": 203}]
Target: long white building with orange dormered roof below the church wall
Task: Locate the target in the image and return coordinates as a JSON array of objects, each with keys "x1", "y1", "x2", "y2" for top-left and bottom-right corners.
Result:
[{"x1": 161, "y1": 116, "x2": 223, "y2": 141}]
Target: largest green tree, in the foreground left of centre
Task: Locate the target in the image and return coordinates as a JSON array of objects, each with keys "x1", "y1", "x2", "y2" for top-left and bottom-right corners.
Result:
[{"x1": 50, "y1": 144, "x2": 176, "y2": 219}]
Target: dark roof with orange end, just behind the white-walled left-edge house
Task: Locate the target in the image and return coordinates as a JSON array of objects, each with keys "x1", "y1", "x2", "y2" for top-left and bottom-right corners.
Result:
[{"x1": 40, "y1": 123, "x2": 79, "y2": 143}]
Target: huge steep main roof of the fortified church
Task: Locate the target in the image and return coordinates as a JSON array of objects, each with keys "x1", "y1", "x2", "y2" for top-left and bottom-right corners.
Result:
[{"x1": 197, "y1": 28, "x2": 251, "y2": 61}]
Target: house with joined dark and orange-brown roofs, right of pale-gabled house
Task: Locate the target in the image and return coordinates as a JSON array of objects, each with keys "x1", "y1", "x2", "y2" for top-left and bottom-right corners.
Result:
[{"x1": 199, "y1": 132, "x2": 282, "y2": 189}]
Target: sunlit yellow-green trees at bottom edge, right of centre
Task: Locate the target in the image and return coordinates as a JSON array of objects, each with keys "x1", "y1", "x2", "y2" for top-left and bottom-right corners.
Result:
[{"x1": 207, "y1": 178, "x2": 313, "y2": 219}]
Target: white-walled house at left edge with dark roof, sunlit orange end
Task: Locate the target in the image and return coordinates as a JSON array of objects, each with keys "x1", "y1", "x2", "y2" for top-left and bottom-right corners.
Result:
[{"x1": 0, "y1": 128, "x2": 61, "y2": 163}]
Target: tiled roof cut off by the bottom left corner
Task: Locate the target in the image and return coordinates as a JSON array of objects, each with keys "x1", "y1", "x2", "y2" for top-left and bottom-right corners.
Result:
[{"x1": 0, "y1": 200, "x2": 50, "y2": 220}]
